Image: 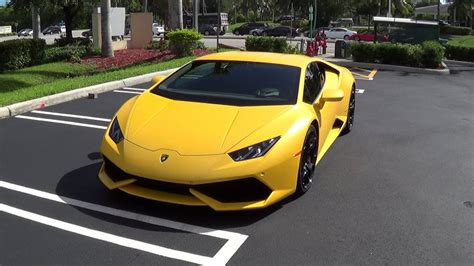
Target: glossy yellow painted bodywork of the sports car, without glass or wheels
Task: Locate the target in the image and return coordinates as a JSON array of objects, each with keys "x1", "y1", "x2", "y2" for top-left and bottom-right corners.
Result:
[{"x1": 99, "y1": 52, "x2": 355, "y2": 210}]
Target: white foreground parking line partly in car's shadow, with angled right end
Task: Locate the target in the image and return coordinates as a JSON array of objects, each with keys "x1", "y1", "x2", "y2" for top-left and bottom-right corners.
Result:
[{"x1": 0, "y1": 181, "x2": 248, "y2": 265}]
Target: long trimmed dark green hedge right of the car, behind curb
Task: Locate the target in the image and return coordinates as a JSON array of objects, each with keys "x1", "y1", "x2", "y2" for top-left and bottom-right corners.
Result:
[{"x1": 350, "y1": 41, "x2": 444, "y2": 68}]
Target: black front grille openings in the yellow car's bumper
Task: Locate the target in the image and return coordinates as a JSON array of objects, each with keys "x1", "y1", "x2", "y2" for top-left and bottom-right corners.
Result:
[{"x1": 104, "y1": 156, "x2": 272, "y2": 203}]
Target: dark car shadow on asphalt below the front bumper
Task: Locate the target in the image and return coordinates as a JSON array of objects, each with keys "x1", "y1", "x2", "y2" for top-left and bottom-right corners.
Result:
[{"x1": 52, "y1": 158, "x2": 296, "y2": 231}]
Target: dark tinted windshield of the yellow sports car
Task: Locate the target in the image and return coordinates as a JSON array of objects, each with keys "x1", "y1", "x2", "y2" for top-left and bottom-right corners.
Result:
[{"x1": 152, "y1": 61, "x2": 300, "y2": 106}]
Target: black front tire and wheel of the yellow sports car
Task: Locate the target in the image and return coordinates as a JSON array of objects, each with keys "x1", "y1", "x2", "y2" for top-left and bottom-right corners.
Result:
[{"x1": 295, "y1": 125, "x2": 319, "y2": 196}]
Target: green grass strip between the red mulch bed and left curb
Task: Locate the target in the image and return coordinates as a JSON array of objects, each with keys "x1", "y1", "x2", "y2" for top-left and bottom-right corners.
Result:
[{"x1": 0, "y1": 56, "x2": 195, "y2": 106}]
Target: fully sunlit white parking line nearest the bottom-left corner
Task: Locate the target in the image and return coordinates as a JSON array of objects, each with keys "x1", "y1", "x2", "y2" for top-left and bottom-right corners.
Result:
[{"x1": 0, "y1": 203, "x2": 212, "y2": 264}]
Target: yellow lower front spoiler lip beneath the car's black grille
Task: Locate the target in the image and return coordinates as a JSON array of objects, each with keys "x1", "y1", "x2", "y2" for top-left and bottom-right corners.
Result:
[{"x1": 99, "y1": 164, "x2": 294, "y2": 211}]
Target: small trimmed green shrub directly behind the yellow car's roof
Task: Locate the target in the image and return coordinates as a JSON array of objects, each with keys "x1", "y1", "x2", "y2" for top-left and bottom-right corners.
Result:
[{"x1": 245, "y1": 36, "x2": 294, "y2": 53}]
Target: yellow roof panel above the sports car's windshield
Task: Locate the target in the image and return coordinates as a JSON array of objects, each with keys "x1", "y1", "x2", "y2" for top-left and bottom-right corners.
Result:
[{"x1": 196, "y1": 51, "x2": 319, "y2": 68}]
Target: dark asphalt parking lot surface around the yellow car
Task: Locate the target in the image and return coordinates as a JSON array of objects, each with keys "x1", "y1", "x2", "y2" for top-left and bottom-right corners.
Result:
[{"x1": 0, "y1": 65, "x2": 474, "y2": 265}]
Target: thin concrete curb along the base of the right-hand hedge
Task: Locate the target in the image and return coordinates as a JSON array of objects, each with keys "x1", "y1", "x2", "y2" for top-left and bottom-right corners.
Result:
[{"x1": 323, "y1": 57, "x2": 450, "y2": 75}]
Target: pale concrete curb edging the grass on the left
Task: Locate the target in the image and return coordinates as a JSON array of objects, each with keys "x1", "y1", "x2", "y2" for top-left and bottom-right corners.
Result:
[{"x1": 0, "y1": 68, "x2": 177, "y2": 119}]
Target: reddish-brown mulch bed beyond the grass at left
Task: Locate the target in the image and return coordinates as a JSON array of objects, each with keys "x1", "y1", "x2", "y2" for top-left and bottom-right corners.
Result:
[{"x1": 81, "y1": 49, "x2": 211, "y2": 69}]
